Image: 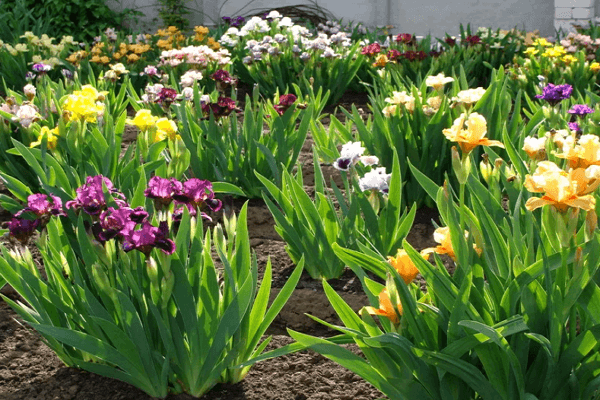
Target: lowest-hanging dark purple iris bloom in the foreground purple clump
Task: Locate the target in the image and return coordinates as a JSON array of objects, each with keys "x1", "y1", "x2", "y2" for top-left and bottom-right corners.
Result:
[{"x1": 123, "y1": 221, "x2": 175, "y2": 256}]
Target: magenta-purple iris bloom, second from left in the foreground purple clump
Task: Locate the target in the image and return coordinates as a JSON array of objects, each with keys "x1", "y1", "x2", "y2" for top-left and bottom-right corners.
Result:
[{"x1": 65, "y1": 175, "x2": 127, "y2": 215}]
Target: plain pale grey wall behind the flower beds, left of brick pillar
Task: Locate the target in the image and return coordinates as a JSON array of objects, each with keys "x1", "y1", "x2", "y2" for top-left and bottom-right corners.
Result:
[{"x1": 110, "y1": 0, "x2": 555, "y2": 37}]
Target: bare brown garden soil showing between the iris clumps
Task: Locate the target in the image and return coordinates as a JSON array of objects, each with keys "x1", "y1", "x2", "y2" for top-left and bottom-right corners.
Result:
[{"x1": 0, "y1": 95, "x2": 439, "y2": 400}]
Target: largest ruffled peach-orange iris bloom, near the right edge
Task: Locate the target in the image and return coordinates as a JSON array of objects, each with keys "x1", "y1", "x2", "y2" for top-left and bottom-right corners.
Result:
[{"x1": 525, "y1": 161, "x2": 600, "y2": 212}]
